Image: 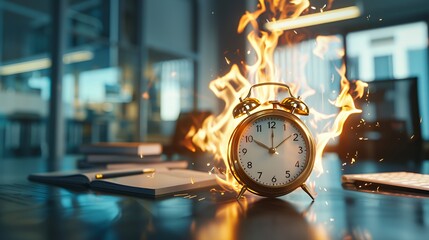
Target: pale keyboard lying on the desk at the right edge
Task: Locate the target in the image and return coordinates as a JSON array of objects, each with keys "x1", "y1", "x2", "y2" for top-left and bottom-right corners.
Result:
[{"x1": 342, "y1": 172, "x2": 429, "y2": 193}]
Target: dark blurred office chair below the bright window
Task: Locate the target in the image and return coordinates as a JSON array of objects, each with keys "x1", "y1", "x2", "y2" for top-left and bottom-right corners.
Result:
[{"x1": 338, "y1": 77, "x2": 422, "y2": 162}]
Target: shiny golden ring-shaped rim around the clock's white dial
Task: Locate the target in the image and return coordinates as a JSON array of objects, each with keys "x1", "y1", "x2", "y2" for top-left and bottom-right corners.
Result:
[{"x1": 228, "y1": 109, "x2": 315, "y2": 197}]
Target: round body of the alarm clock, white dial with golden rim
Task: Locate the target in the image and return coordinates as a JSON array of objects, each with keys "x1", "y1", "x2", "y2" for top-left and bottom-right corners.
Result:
[{"x1": 230, "y1": 109, "x2": 314, "y2": 195}]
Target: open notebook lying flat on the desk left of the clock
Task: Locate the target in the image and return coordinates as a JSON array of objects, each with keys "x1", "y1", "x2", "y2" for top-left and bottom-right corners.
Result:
[{"x1": 28, "y1": 168, "x2": 217, "y2": 197}]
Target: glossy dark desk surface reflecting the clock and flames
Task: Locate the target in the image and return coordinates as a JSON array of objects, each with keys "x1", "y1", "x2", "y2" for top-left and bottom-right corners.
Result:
[{"x1": 0, "y1": 156, "x2": 429, "y2": 240}]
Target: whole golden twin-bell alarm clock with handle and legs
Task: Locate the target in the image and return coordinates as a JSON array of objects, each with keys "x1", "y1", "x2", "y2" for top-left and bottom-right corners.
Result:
[{"x1": 228, "y1": 82, "x2": 315, "y2": 200}]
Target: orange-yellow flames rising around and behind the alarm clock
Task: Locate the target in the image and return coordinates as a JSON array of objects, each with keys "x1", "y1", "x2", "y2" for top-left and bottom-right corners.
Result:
[{"x1": 192, "y1": 0, "x2": 366, "y2": 190}]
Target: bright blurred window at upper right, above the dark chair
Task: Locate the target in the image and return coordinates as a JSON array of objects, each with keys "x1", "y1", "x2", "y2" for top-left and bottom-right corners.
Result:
[{"x1": 346, "y1": 22, "x2": 429, "y2": 140}]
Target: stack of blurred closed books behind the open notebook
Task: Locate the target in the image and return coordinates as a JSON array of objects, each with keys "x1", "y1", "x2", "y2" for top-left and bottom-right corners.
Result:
[{"x1": 78, "y1": 142, "x2": 187, "y2": 169}]
